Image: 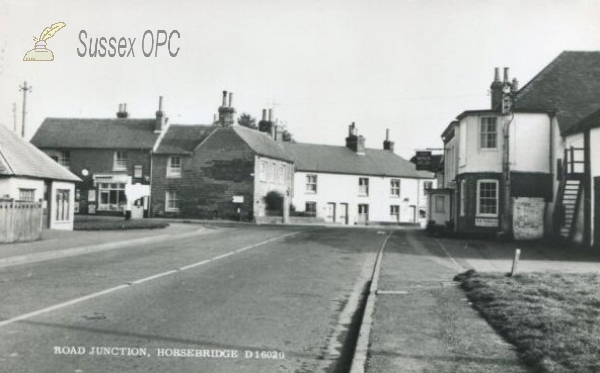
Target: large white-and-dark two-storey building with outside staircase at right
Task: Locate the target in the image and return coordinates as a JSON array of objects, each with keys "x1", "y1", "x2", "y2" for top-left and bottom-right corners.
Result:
[{"x1": 430, "y1": 52, "x2": 600, "y2": 242}]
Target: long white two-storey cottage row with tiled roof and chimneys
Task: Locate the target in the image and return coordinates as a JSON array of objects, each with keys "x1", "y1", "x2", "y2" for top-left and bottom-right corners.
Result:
[{"x1": 284, "y1": 123, "x2": 434, "y2": 225}]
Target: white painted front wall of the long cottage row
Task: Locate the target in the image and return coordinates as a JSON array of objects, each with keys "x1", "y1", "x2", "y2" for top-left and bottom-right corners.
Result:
[{"x1": 292, "y1": 172, "x2": 436, "y2": 225}]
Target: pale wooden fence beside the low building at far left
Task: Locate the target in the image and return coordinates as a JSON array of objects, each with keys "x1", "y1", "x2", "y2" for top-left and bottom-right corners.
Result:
[{"x1": 0, "y1": 200, "x2": 43, "y2": 243}]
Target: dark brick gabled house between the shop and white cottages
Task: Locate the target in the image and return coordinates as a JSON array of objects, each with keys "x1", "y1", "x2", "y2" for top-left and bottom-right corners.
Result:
[{"x1": 152, "y1": 92, "x2": 293, "y2": 220}]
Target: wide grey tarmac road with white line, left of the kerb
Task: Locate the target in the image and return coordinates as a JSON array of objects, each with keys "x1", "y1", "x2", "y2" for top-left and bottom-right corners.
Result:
[{"x1": 0, "y1": 226, "x2": 385, "y2": 373}]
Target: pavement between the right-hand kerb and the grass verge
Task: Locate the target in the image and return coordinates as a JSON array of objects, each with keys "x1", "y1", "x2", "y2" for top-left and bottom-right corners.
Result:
[{"x1": 364, "y1": 231, "x2": 600, "y2": 373}]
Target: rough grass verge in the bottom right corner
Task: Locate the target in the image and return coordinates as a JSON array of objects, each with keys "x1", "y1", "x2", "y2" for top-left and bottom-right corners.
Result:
[{"x1": 461, "y1": 273, "x2": 600, "y2": 373}]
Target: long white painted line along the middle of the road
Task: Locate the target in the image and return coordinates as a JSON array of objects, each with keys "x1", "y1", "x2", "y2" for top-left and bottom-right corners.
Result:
[{"x1": 0, "y1": 231, "x2": 302, "y2": 328}]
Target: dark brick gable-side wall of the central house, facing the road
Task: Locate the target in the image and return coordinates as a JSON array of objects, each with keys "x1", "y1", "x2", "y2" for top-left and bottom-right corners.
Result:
[{"x1": 152, "y1": 129, "x2": 255, "y2": 220}]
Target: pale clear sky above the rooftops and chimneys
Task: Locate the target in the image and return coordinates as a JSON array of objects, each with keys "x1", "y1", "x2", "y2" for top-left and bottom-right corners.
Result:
[{"x1": 0, "y1": 0, "x2": 600, "y2": 158}]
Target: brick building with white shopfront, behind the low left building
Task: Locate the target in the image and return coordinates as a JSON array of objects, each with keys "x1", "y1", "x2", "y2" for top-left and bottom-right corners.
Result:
[{"x1": 31, "y1": 100, "x2": 167, "y2": 217}]
